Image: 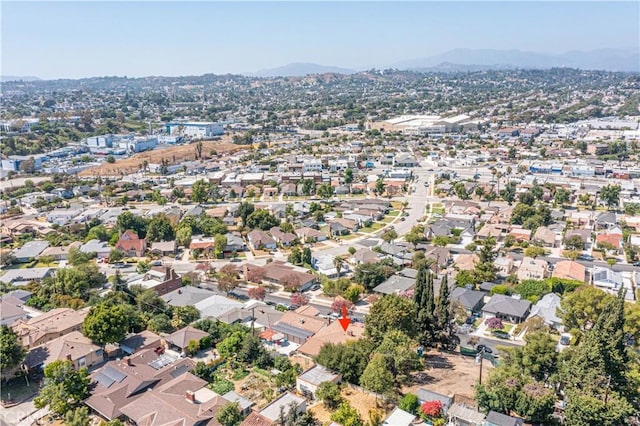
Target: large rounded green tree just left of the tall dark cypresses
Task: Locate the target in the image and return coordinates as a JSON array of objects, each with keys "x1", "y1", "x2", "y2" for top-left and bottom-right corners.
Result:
[{"x1": 365, "y1": 294, "x2": 416, "y2": 343}]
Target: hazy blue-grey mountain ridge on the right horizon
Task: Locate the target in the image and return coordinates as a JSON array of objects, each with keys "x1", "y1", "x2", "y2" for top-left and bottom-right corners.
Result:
[{"x1": 391, "y1": 49, "x2": 640, "y2": 72}]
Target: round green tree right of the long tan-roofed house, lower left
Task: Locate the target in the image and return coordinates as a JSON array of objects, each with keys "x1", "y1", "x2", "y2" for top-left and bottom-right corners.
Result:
[{"x1": 82, "y1": 304, "x2": 129, "y2": 346}]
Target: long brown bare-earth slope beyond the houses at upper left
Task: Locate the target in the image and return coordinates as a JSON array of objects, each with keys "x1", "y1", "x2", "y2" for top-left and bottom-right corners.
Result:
[{"x1": 80, "y1": 135, "x2": 247, "y2": 176}]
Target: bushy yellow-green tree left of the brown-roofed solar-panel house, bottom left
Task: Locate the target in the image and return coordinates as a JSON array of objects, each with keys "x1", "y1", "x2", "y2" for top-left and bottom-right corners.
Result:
[{"x1": 33, "y1": 360, "x2": 91, "y2": 415}]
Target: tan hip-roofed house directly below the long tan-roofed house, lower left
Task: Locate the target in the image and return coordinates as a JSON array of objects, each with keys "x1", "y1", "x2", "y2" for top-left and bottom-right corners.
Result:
[{"x1": 24, "y1": 331, "x2": 104, "y2": 370}]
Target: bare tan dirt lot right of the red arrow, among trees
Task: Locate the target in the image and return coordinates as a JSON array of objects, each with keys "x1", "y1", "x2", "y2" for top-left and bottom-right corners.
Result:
[{"x1": 403, "y1": 351, "x2": 493, "y2": 398}]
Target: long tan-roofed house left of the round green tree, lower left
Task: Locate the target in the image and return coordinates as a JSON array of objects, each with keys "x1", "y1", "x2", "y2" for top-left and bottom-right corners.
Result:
[{"x1": 11, "y1": 308, "x2": 89, "y2": 349}]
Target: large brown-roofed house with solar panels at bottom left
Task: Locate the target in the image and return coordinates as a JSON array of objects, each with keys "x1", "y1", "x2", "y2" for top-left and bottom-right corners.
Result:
[{"x1": 84, "y1": 349, "x2": 195, "y2": 425}]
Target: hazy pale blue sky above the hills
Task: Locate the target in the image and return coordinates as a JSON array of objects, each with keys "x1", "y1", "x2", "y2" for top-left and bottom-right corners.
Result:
[{"x1": 0, "y1": 0, "x2": 640, "y2": 79}]
